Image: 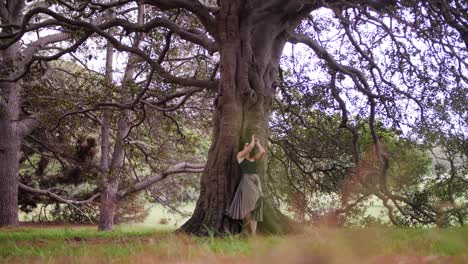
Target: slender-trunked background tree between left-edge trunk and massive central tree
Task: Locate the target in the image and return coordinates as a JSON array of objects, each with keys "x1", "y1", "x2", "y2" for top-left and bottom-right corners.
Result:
[{"x1": 12, "y1": 3, "x2": 208, "y2": 230}]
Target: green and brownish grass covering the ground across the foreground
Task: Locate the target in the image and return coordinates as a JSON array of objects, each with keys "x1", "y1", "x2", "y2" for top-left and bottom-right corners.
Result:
[{"x1": 0, "y1": 226, "x2": 468, "y2": 264}]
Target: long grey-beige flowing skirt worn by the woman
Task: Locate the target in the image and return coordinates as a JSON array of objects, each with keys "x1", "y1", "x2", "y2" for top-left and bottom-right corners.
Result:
[{"x1": 227, "y1": 174, "x2": 263, "y2": 222}]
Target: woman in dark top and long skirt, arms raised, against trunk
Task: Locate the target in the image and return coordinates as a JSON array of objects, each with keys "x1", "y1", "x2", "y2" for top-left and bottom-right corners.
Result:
[{"x1": 228, "y1": 135, "x2": 265, "y2": 234}]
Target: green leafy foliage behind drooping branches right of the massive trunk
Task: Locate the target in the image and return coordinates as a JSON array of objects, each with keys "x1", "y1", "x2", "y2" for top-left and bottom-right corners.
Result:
[{"x1": 267, "y1": 101, "x2": 456, "y2": 226}]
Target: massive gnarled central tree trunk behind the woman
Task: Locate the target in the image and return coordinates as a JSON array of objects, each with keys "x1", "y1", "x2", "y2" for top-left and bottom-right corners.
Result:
[{"x1": 181, "y1": 0, "x2": 308, "y2": 235}]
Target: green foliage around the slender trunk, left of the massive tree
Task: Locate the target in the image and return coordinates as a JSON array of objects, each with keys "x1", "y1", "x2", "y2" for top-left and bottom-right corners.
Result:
[{"x1": 20, "y1": 52, "x2": 213, "y2": 223}]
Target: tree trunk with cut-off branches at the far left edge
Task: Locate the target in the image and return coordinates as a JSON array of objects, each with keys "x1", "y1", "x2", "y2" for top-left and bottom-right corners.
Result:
[{"x1": 0, "y1": 0, "x2": 75, "y2": 226}]
